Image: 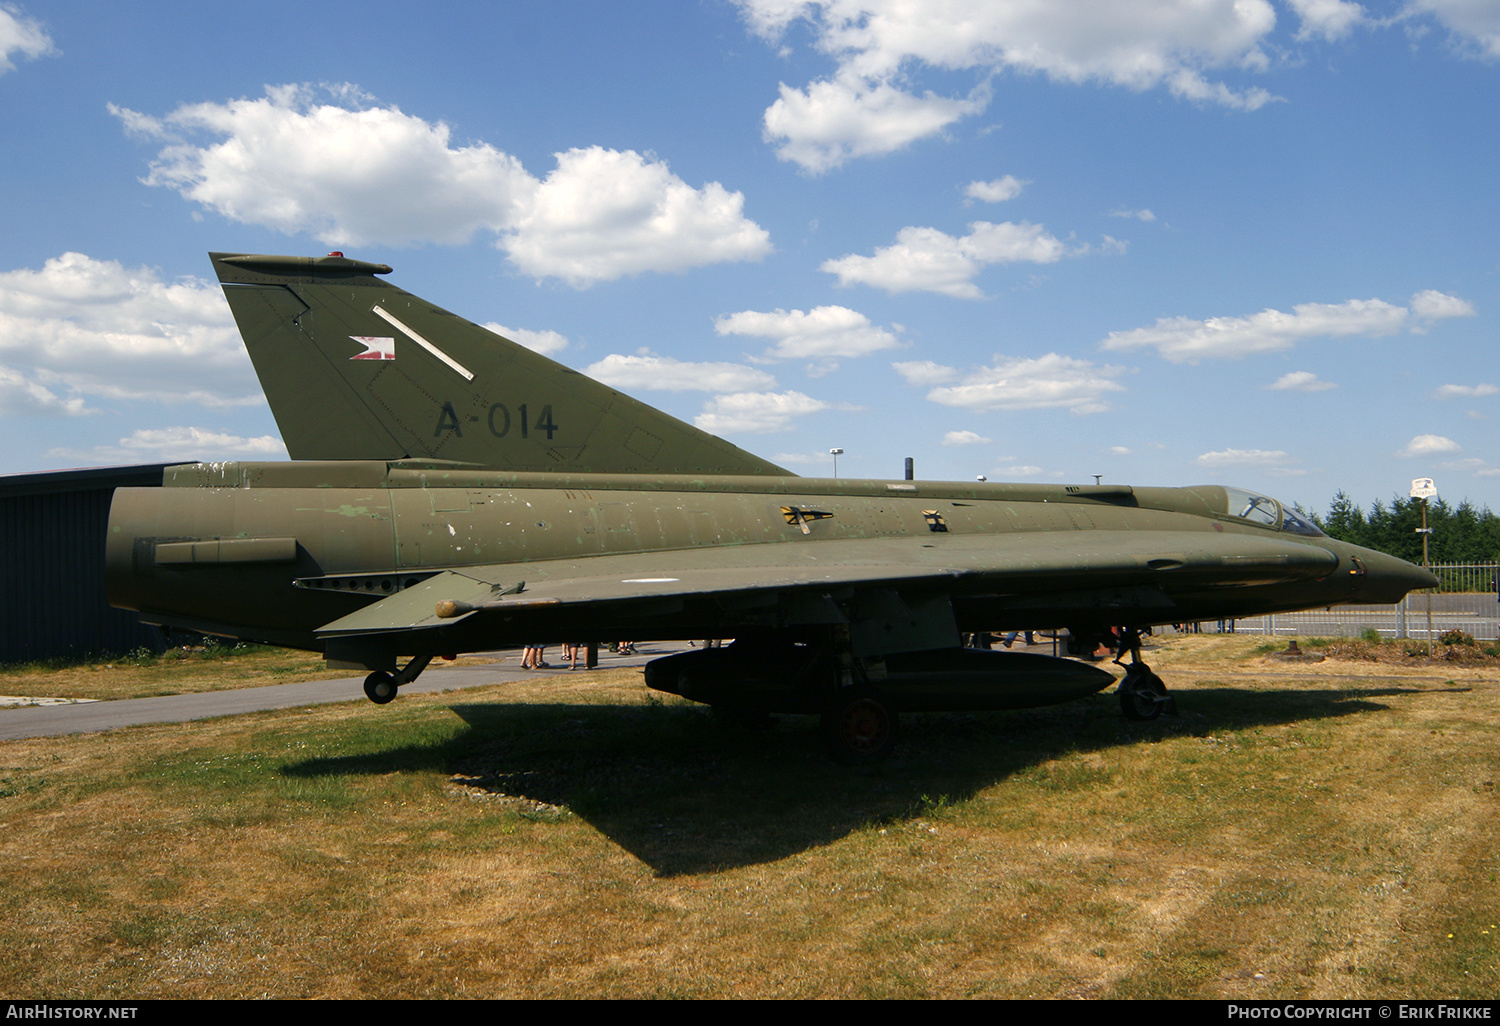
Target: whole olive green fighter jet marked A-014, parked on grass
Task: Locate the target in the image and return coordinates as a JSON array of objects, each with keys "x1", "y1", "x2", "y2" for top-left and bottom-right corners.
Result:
[{"x1": 107, "y1": 254, "x2": 1436, "y2": 759}]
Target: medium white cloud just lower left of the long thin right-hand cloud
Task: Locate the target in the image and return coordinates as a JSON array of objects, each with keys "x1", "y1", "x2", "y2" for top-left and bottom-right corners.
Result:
[{"x1": 927, "y1": 353, "x2": 1125, "y2": 414}]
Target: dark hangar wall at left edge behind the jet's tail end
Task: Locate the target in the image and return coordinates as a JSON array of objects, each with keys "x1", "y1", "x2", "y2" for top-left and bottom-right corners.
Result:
[{"x1": 0, "y1": 464, "x2": 170, "y2": 663}]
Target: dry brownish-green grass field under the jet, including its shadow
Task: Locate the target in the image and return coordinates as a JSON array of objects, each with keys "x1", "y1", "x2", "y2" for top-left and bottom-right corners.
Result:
[{"x1": 0, "y1": 636, "x2": 1500, "y2": 999}]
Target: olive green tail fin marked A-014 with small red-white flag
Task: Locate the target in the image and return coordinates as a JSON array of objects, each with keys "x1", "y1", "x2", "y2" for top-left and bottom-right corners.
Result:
[{"x1": 219, "y1": 254, "x2": 792, "y2": 477}]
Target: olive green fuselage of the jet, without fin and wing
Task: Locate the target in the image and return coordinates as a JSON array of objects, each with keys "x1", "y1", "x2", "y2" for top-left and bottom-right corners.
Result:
[{"x1": 108, "y1": 461, "x2": 1430, "y2": 654}]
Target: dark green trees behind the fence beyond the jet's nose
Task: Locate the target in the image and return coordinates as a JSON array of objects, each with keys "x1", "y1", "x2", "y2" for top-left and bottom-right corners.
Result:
[{"x1": 1296, "y1": 492, "x2": 1500, "y2": 563}]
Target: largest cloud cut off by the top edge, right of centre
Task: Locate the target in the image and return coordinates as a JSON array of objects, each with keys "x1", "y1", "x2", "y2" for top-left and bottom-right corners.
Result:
[{"x1": 738, "y1": 0, "x2": 1277, "y2": 173}]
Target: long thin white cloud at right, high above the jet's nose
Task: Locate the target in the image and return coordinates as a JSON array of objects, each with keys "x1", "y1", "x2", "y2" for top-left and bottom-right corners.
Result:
[{"x1": 1101, "y1": 291, "x2": 1473, "y2": 363}]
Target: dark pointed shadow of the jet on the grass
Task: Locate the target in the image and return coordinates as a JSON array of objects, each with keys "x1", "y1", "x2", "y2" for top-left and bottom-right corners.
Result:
[{"x1": 273, "y1": 686, "x2": 1464, "y2": 878}]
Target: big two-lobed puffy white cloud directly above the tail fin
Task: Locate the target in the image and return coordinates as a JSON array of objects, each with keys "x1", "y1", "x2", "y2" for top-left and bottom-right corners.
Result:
[{"x1": 110, "y1": 86, "x2": 771, "y2": 288}]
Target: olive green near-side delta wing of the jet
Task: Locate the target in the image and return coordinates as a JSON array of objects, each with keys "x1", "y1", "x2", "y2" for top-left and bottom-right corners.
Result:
[{"x1": 318, "y1": 531, "x2": 1338, "y2": 639}]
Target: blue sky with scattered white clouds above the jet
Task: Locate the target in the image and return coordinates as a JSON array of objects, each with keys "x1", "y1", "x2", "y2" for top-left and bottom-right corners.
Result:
[{"x1": 0, "y1": 0, "x2": 1500, "y2": 510}]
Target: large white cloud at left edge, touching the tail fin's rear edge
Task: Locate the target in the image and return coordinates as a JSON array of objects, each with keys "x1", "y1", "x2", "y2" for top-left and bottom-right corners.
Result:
[{"x1": 0, "y1": 254, "x2": 264, "y2": 407}]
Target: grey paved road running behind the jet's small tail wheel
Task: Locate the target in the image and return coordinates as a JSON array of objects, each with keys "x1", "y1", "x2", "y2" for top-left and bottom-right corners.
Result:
[{"x1": 0, "y1": 642, "x2": 687, "y2": 740}]
